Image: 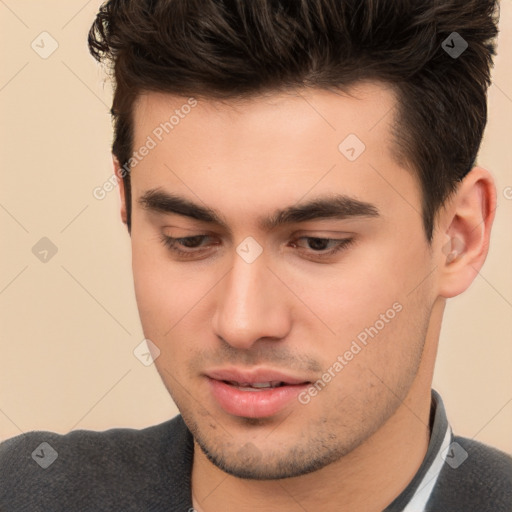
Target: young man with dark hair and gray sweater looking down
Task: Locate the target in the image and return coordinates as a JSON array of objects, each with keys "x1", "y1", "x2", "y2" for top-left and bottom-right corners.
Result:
[{"x1": 0, "y1": 0, "x2": 512, "y2": 512}]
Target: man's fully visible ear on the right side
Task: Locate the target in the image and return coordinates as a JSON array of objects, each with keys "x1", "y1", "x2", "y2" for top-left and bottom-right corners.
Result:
[{"x1": 438, "y1": 167, "x2": 496, "y2": 298}]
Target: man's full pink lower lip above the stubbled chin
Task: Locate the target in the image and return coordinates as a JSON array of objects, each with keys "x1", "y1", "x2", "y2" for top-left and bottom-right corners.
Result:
[{"x1": 208, "y1": 378, "x2": 308, "y2": 418}]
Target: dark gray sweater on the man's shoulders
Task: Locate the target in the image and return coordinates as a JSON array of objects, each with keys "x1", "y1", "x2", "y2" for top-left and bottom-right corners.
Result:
[{"x1": 0, "y1": 391, "x2": 512, "y2": 512}]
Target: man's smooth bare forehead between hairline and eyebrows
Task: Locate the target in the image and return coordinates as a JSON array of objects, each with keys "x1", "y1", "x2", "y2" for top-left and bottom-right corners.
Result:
[{"x1": 131, "y1": 83, "x2": 417, "y2": 228}]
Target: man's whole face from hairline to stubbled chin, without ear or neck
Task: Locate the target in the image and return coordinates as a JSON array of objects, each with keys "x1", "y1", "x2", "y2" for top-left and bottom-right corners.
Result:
[{"x1": 126, "y1": 83, "x2": 435, "y2": 479}]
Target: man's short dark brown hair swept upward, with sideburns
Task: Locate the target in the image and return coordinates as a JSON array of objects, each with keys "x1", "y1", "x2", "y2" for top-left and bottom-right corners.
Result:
[{"x1": 89, "y1": 0, "x2": 499, "y2": 241}]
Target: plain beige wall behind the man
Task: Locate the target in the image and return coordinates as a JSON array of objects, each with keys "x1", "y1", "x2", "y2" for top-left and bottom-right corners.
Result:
[{"x1": 0, "y1": 0, "x2": 512, "y2": 453}]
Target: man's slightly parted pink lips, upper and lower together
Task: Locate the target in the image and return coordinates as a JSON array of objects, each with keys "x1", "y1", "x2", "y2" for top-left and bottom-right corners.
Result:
[{"x1": 206, "y1": 369, "x2": 311, "y2": 418}]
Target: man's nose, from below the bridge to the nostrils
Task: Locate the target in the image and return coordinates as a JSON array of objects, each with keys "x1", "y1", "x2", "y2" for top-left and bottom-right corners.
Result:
[{"x1": 213, "y1": 249, "x2": 291, "y2": 349}]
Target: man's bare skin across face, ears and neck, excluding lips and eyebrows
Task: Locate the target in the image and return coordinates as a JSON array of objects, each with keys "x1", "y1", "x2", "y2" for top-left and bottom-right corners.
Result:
[{"x1": 115, "y1": 82, "x2": 496, "y2": 512}]
